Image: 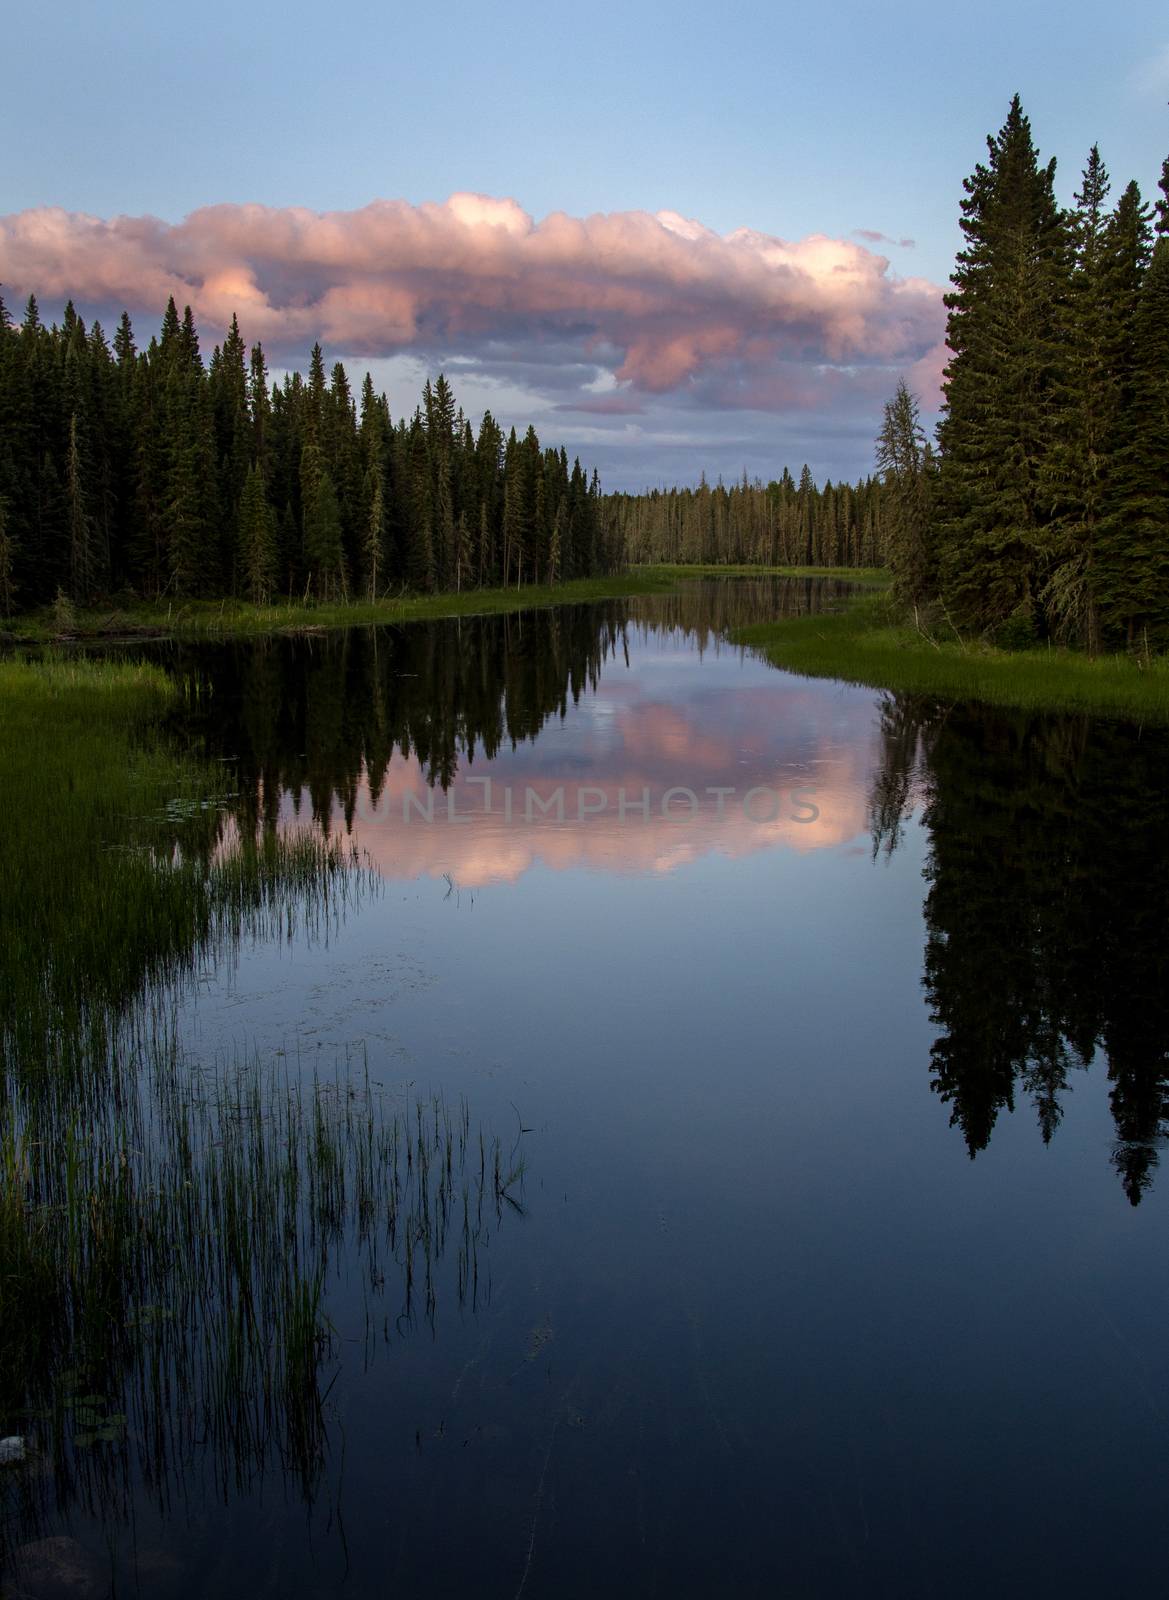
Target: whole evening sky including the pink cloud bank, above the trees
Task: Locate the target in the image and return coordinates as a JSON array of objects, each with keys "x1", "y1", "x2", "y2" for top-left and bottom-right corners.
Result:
[{"x1": 0, "y1": 0, "x2": 1169, "y2": 490}]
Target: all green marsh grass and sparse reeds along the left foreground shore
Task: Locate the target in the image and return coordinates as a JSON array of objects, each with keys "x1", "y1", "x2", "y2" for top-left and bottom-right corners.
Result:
[{"x1": 0, "y1": 659, "x2": 523, "y2": 1566}]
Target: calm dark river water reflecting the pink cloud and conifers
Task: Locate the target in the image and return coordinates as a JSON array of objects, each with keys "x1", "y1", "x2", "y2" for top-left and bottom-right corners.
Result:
[{"x1": 2, "y1": 582, "x2": 1169, "y2": 1600}]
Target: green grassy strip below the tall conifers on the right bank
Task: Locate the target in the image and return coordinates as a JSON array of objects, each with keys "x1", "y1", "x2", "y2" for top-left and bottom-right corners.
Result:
[{"x1": 732, "y1": 594, "x2": 1169, "y2": 723}]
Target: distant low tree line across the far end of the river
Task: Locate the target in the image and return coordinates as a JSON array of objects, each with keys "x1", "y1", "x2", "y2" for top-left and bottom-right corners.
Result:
[{"x1": 606, "y1": 464, "x2": 886, "y2": 566}]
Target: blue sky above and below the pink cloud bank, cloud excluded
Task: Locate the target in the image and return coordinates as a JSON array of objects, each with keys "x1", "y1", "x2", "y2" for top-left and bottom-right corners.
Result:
[{"x1": 0, "y1": 0, "x2": 1169, "y2": 486}]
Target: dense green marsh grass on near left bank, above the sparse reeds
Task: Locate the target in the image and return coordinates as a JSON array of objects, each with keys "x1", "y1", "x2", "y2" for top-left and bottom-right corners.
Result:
[{"x1": 0, "y1": 659, "x2": 373, "y2": 1109}]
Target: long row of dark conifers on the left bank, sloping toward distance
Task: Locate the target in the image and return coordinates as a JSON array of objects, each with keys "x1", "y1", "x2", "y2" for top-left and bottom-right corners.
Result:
[{"x1": 0, "y1": 296, "x2": 617, "y2": 613}]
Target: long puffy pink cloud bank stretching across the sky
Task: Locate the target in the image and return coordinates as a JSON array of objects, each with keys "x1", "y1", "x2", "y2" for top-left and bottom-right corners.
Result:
[{"x1": 0, "y1": 194, "x2": 944, "y2": 408}]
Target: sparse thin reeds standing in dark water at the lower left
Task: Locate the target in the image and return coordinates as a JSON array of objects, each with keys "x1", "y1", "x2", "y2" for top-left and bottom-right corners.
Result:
[{"x1": 0, "y1": 1050, "x2": 523, "y2": 1523}]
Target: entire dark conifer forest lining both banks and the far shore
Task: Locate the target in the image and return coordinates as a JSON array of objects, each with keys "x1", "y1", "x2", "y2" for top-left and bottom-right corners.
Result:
[{"x1": 0, "y1": 96, "x2": 1169, "y2": 656}]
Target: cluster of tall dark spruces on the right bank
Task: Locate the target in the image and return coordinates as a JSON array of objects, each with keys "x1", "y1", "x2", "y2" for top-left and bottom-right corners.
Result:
[{"x1": 878, "y1": 96, "x2": 1169, "y2": 651}]
